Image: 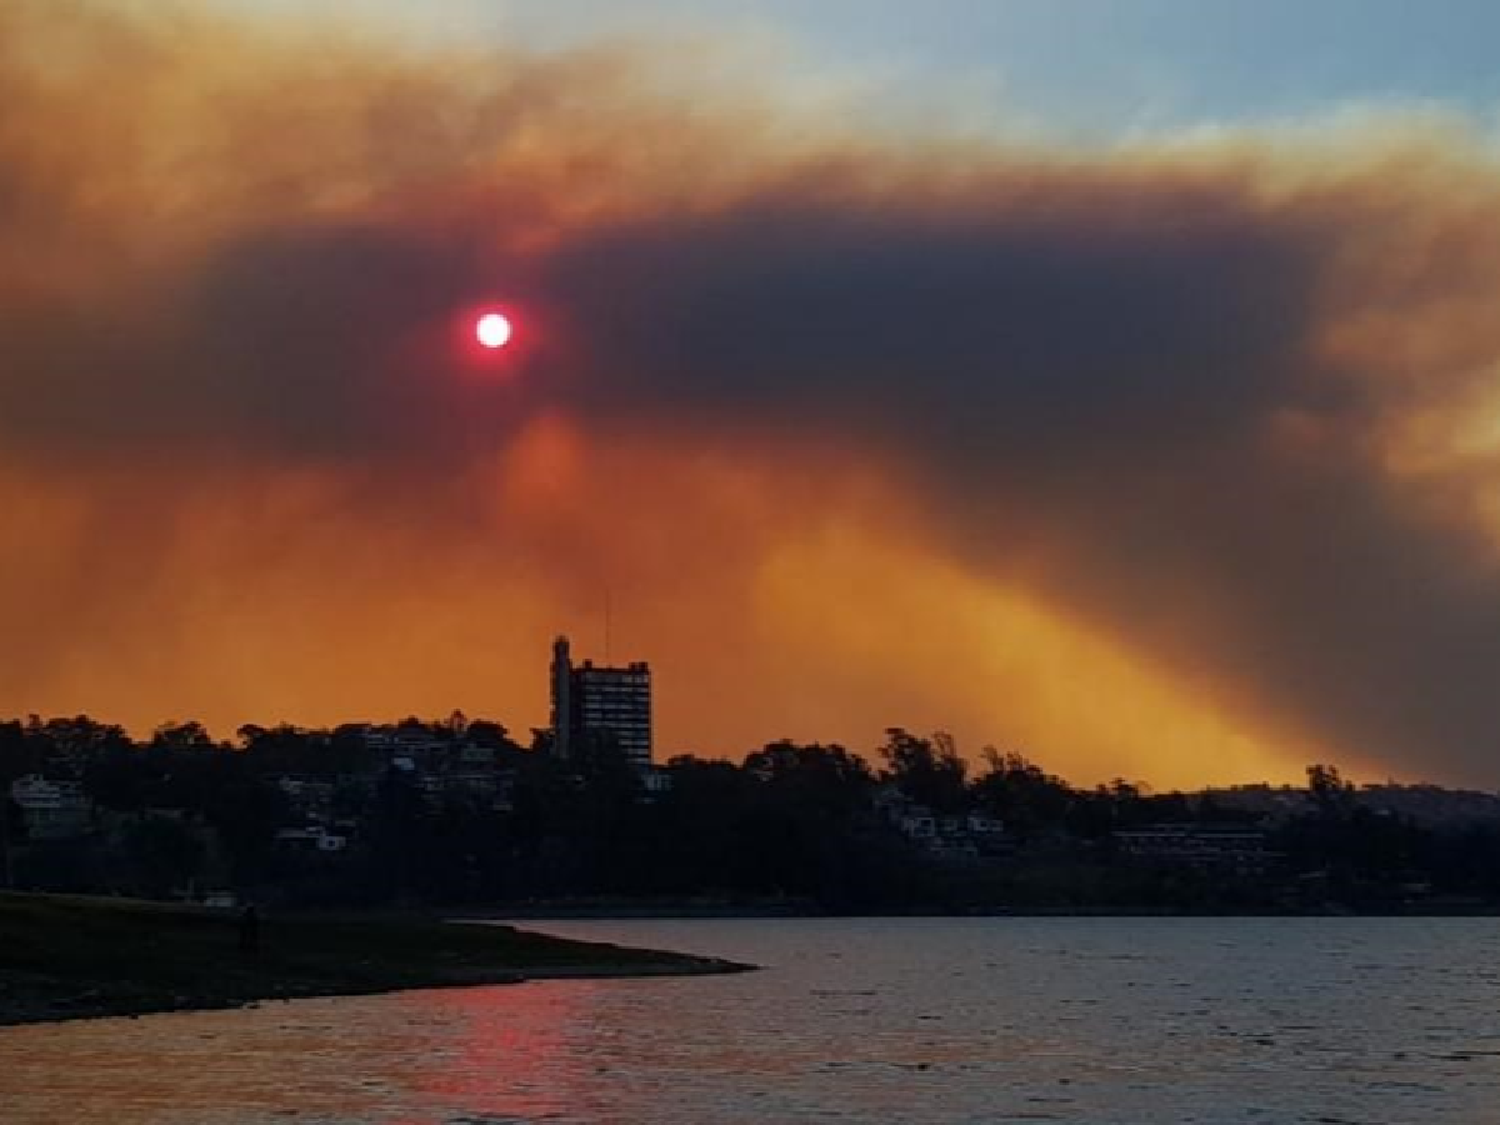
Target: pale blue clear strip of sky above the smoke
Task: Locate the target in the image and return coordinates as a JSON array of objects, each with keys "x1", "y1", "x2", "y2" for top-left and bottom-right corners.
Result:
[{"x1": 222, "y1": 0, "x2": 1500, "y2": 135}]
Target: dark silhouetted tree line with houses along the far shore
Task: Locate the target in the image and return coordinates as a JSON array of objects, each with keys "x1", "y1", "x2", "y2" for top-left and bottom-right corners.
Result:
[{"x1": 0, "y1": 716, "x2": 1500, "y2": 912}]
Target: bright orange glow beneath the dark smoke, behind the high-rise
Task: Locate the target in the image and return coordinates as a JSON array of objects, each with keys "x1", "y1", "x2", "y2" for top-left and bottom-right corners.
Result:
[{"x1": 0, "y1": 432, "x2": 1326, "y2": 788}]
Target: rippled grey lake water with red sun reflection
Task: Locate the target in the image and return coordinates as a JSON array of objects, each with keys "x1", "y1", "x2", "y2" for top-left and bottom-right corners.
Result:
[{"x1": 0, "y1": 918, "x2": 1500, "y2": 1125}]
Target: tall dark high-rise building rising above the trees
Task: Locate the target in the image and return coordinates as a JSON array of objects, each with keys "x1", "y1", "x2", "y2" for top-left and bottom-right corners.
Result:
[{"x1": 552, "y1": 636, "x2": 651, "y2": 768}]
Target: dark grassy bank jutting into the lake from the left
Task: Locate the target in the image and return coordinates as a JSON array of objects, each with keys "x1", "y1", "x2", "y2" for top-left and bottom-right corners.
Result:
[{"x1": 0, "y1": 894, "x2": 746, "y2": 1025}]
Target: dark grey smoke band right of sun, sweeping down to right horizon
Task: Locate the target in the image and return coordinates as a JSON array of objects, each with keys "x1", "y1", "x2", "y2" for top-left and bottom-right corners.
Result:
[{"x1": 531, "y1": 180, "x2": 1500, "y2": 780}]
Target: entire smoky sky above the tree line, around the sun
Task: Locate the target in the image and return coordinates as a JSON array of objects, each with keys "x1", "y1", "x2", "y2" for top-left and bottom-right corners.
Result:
[{"x1": 0, "y1": 0, "x2": 1500, "y2": 789}]
